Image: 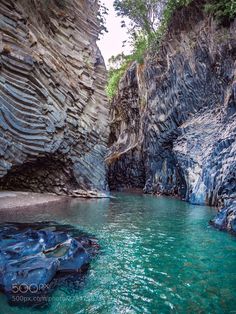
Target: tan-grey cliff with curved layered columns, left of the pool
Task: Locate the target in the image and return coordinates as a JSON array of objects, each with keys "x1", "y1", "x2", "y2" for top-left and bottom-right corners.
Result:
[{"x1": 0, "y1": 0, "x2": 109, "y2": 194}]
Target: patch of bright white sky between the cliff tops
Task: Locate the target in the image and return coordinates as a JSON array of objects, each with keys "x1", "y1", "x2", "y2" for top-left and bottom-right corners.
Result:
[{"x1": 97, "y1": 0, "x2": 130, "y2": 65}]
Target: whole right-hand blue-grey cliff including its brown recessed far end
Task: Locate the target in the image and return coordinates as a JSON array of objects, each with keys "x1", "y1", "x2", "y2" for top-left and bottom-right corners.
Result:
[{"x1": 107, "y1": 4, "x2": 236, "y2": 232}]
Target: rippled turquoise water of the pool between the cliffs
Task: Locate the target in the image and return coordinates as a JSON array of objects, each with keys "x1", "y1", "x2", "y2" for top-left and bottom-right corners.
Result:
[{"x1": 0, "y1": 193, "x2": 236, "y2": 314}]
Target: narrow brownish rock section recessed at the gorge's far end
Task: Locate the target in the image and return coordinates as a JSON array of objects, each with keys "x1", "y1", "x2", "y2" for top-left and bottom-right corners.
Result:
[{"x1": 107, "y1": 64, "x2": 145, "y2": 190}]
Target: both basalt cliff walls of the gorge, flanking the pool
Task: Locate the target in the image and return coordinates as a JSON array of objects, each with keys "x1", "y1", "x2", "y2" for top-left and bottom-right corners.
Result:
[{"x1": 0, "y1": 0, "x2": 236, "y2": 231}]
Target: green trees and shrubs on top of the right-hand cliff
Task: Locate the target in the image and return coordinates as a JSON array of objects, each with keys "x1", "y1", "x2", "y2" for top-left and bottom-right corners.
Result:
[{"x1": 107, "y1": 0, "x2": 236, "y2": 100}]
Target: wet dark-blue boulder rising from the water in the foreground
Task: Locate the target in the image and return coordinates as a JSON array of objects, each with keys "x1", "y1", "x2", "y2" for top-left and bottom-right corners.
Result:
[{"x1": 0, "y1": 222, "x2": 99, "y2": 306}]
